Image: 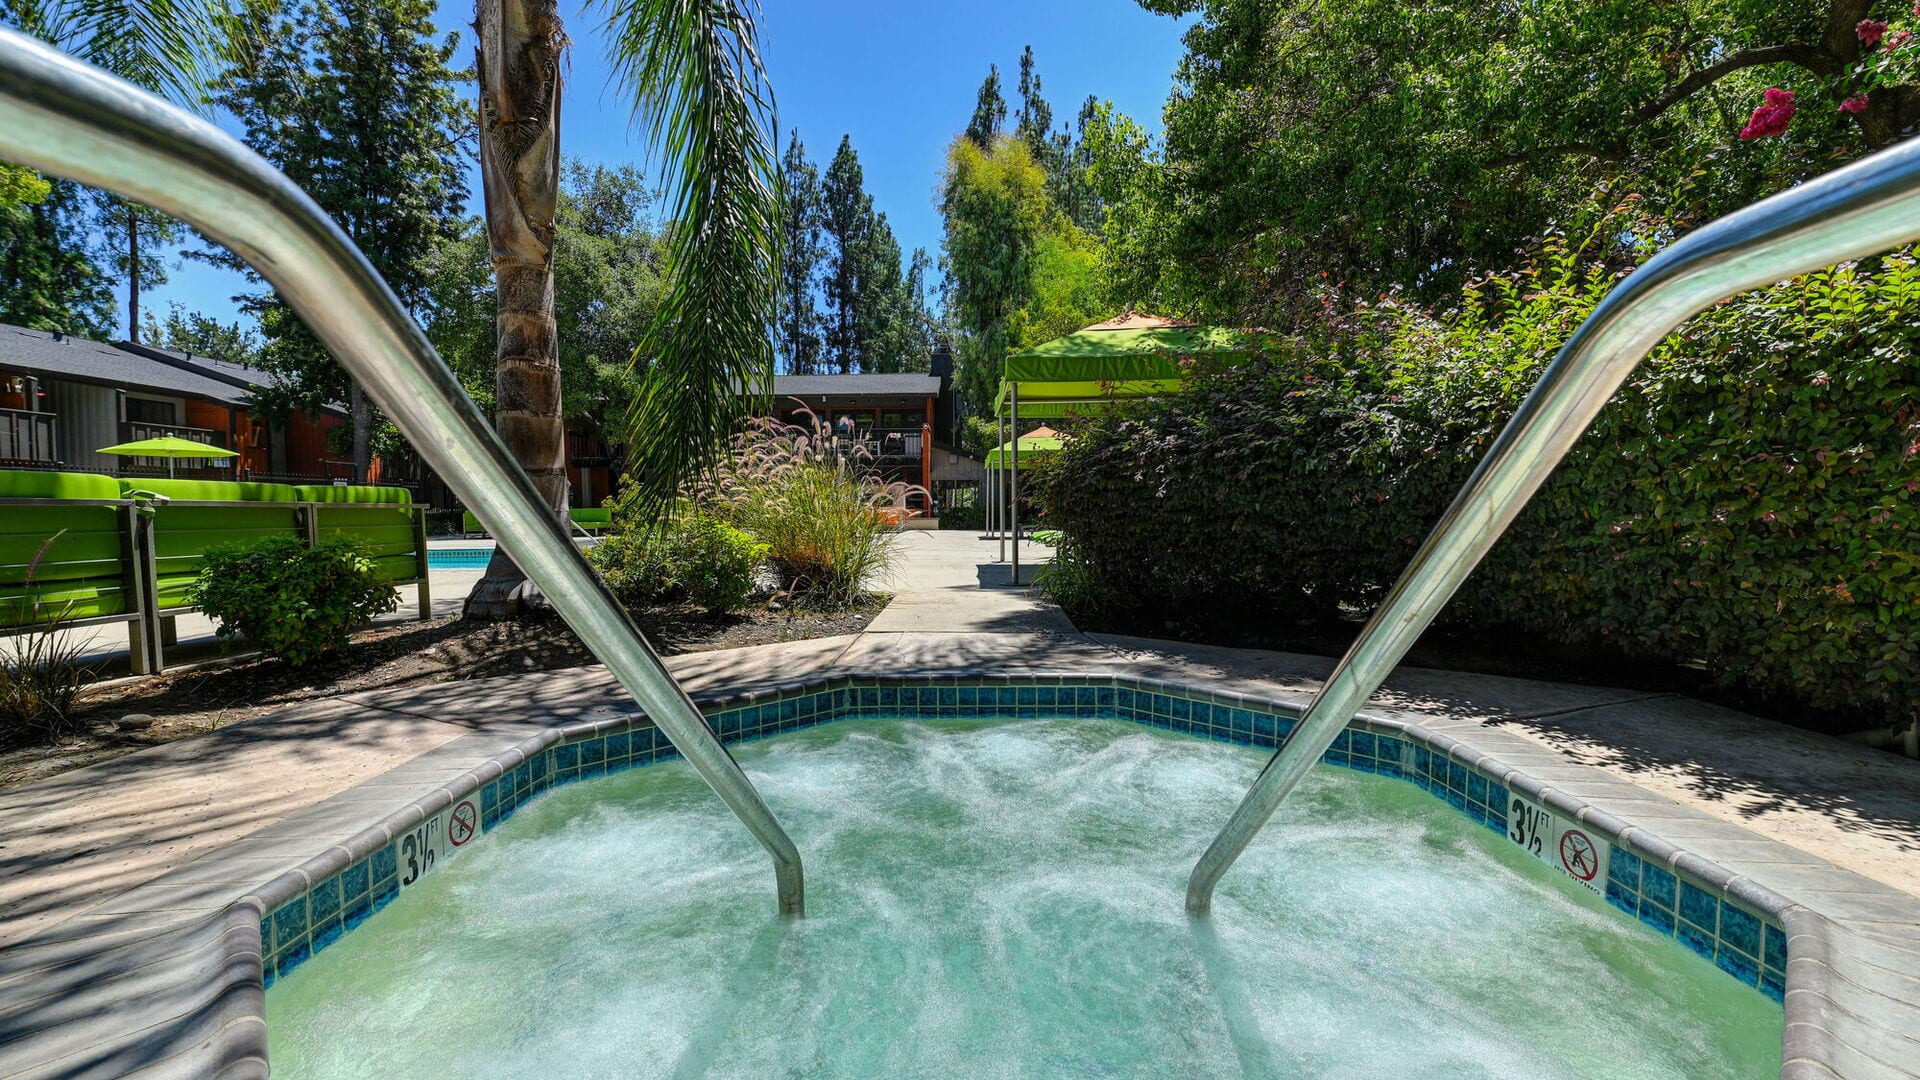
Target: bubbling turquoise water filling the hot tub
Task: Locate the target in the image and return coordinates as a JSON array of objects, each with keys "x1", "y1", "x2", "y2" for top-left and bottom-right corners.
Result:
[{"x1": 267, "y1": 719, "x2": 1782, "y2": 1078}]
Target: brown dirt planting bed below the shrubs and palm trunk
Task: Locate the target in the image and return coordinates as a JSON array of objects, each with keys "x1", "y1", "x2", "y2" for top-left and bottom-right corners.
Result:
[{"x1": 0, "y1": 598, "x2": 887, "y2": 788}]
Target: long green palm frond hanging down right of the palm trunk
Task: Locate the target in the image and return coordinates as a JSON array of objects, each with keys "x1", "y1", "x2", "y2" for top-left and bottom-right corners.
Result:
[{"x1": 601, "y1": 0, "x2": 781, "y2": 517}]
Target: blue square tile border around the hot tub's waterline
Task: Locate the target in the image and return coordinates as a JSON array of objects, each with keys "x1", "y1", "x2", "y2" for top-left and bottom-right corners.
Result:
[{"x1": 259, "y1": 676, "x2": 1788, "y2": 1001}]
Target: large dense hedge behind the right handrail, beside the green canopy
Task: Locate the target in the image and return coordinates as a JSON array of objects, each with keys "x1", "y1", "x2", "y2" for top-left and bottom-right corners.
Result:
[{"x1": 1043, "y1": 217, "x2": 1920, "y2": 723}]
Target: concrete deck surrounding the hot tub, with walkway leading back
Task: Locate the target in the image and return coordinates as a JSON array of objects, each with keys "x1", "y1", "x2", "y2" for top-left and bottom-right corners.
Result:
[{"x1": 0, "y1": 532, "x2": 1920, "y2": 1078}]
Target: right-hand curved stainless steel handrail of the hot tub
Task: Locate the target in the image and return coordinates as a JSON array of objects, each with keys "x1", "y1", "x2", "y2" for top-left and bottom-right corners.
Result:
[{"x1": 1187, "y1": 140, "x2": 1920, "y2": 915}]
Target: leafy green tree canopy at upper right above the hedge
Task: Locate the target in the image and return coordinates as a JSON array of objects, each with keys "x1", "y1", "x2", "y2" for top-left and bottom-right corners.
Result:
[{"x1": 1121, "y1": 0, "x2": 1920, "y2": 321}]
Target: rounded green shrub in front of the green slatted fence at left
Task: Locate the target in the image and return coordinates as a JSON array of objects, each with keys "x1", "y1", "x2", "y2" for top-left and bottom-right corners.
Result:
[{"x1": 188, "y1": 536, "x2": 397, "y2": 667}]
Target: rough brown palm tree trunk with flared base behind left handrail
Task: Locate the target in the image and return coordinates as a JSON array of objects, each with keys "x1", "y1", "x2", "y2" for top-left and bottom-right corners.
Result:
[{"x1": 467, "y1": 0, "x2": 566, "y2": 619}]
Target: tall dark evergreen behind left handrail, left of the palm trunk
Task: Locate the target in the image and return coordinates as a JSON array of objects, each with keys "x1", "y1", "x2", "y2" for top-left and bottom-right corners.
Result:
[{"x1": 215, "y1": 0, "x2": 472, "y2": 477}]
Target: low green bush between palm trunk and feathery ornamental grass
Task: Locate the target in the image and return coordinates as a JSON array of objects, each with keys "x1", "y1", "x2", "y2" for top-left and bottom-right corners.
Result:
[{"x1": 588, "y1": 513, "x2": 766, "y2": 613}]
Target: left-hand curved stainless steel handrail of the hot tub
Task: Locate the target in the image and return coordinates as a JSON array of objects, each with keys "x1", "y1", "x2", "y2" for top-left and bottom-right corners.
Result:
[{"x1": 0, "y1": 31, "x2": 804, "y2": 915}]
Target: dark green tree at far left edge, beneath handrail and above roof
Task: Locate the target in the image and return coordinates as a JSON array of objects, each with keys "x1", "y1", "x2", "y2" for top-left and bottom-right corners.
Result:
[{"x1": 0, "y1": 181, "x2": 113, "y2": 338}]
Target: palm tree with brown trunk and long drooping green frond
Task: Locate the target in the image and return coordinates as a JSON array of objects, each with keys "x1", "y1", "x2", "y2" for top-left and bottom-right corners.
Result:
[{"x1": 467, "y1": 0, "x2": 781, "y2": 619}]
